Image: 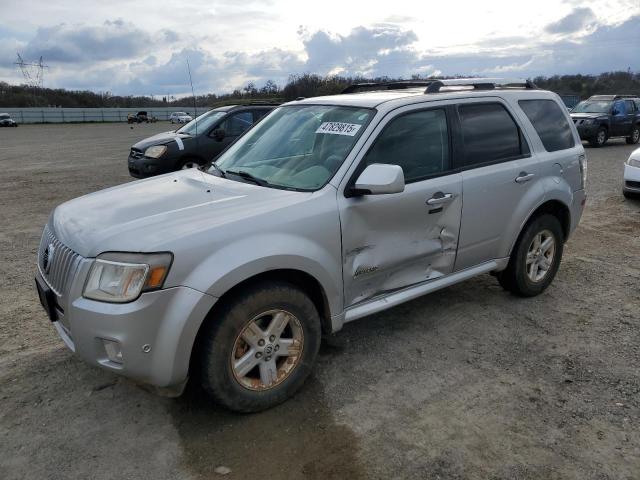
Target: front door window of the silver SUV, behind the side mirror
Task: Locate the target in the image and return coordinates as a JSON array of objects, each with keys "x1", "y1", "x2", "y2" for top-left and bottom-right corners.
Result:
[{"x1": 365, "y1": 110, "x2": 449, "y2": 182}]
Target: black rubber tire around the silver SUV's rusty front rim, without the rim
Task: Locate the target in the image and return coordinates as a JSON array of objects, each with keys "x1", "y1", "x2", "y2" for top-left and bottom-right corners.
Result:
[{"x1": 200, "y1": 282, "x2": 321, "y2": 413}]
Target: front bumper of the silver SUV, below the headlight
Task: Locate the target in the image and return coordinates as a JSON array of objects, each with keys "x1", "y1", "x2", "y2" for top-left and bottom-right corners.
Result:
[{"x1": 38, "y1": 267, "x2": 217, "y2": 388}]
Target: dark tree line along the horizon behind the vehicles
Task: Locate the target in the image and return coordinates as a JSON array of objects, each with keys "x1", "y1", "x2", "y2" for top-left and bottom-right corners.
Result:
[{"x1": 0, "y1": 71, "x2": 640, "y2": 108}]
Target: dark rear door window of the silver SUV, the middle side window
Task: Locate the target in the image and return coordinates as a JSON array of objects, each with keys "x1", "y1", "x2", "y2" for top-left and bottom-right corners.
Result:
[{"x1": 458, "y1": 103, "x2": 528, "y2": 166}]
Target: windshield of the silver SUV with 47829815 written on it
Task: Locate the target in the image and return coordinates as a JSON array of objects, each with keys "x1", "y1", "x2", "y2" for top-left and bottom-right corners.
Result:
[{"x1": 209, "y1": 105, "x2": 374, "y2": 190}]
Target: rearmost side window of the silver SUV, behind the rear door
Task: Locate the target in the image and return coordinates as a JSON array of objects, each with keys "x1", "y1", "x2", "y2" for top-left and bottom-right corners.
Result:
[{"x1": 518, "y1": 100, "x2": 575, "y2": 152}]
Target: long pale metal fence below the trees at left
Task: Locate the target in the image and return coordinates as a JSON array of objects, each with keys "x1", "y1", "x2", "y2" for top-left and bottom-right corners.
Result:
[{"x1": 0, "y1": 107, "x2": 202, "y2": 123}]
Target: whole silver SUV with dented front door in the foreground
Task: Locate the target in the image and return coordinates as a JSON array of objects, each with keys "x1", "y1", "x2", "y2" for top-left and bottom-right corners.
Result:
[{"x1": 36, "y1": 79, "x2": 586, "y2": 412}]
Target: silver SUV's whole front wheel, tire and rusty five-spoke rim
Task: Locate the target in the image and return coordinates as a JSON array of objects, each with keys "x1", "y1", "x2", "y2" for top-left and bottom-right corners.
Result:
[{"x1": 201, "y1": 282, "x2": 321, "y2": 412}]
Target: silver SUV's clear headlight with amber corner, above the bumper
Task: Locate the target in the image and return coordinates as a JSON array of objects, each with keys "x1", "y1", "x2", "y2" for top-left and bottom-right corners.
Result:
[{"x1": 82, "y1": 252, "x2": 173, "y2": 303}]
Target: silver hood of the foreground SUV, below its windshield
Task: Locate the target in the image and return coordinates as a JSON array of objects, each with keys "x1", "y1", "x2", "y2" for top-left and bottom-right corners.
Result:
[{"x1": 52, "y1": 169, "x2": 312, "y2": 257}]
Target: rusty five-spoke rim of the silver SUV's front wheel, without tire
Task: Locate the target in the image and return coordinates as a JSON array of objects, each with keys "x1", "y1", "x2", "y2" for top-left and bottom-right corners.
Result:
[{"x1": 231, "y1": 309, "x2": 304, "y2": 391}]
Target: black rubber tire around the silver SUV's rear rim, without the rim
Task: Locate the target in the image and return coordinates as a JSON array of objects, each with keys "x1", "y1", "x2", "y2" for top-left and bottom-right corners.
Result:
[{"x1": 497, "y1": 214, "x2": 564, "y2": 297}]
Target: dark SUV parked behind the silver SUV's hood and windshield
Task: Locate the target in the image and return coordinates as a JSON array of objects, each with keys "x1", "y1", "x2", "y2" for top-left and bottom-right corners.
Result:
[{"x1": 128, "y1": 104, "x2": 275, "y2": 178}]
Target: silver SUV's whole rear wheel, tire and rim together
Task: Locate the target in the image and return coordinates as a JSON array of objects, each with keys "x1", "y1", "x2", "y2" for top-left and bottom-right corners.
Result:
[{"x1": 498, "y1": 214, "x2": 564, "y2": 297}]
